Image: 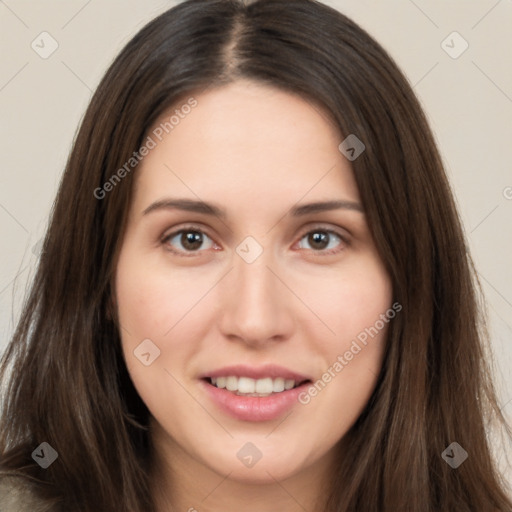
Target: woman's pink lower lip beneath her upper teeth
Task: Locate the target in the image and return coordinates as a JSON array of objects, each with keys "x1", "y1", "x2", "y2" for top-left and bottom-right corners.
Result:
[{"x1": 201, "y1": 380, "x2": 311, "y2": 421}]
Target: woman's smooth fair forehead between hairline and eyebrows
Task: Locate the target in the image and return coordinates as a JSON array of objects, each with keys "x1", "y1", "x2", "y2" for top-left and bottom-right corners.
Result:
[{"x1": 130, "y1": 81, "x2": 358, "y2": 214}]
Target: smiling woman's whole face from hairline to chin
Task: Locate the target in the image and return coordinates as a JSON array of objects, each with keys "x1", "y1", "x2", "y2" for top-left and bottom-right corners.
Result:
[{"x1": 115, "y1": 81, "x2": 394, "y2": 483}]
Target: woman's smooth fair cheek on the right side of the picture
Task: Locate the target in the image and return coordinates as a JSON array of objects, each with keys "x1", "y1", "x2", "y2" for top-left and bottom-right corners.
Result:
[{"x1": 301, "y1": 252, "x2": 396, "y2": 416}]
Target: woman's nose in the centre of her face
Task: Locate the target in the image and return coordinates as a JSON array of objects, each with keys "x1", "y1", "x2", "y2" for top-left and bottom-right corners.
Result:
[{"x1": 219, "y1": 245, "x2": 298, "y2": 347}]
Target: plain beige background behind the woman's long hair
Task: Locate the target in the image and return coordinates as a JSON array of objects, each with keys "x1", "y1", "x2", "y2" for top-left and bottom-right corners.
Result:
[{"x1": 0, "y1": 0, "x2": 512, "y2": 480}]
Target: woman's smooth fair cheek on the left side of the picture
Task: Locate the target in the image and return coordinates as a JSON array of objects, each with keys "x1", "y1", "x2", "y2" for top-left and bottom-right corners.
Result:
[{"x1": 116, "y1": 246, "x2": 218, "y2": 412}]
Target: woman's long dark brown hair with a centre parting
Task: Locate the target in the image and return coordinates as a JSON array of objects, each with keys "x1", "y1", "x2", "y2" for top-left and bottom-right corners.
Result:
[{"x1": 0, "y1": 0, "x2": 512, "y2": 512}]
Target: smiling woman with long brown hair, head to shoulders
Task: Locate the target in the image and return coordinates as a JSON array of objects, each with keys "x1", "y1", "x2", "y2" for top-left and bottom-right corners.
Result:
[{"x1": 0, "y1": 0, "x2": 512, "y2": 512}]
